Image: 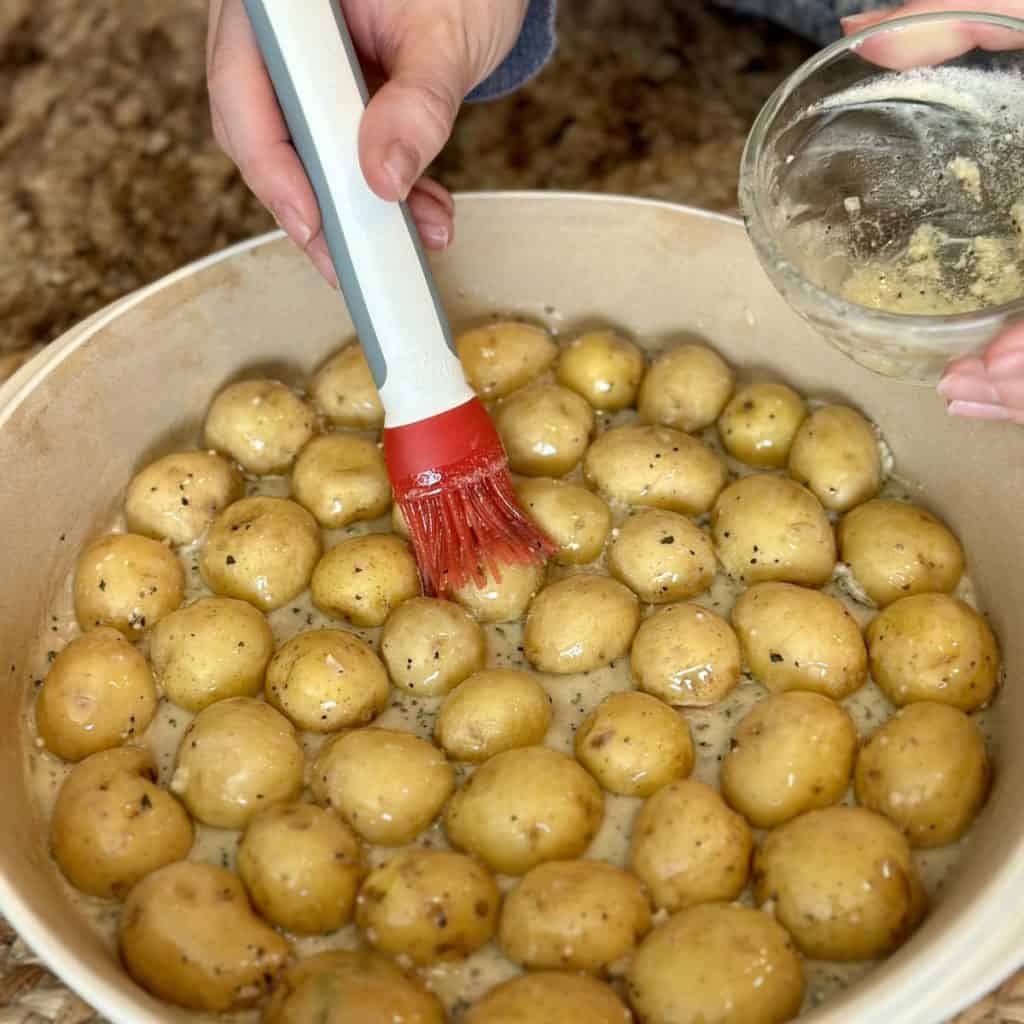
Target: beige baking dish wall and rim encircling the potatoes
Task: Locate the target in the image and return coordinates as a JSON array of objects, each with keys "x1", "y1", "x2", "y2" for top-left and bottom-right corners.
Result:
[{"x1": 0, "y1": 195, "x2": 1024, "y2": 1024}]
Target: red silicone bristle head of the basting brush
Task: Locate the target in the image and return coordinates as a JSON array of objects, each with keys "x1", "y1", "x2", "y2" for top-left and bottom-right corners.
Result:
[{"x1": 384, "y1": 398, "x2": 555, "y2": 596}]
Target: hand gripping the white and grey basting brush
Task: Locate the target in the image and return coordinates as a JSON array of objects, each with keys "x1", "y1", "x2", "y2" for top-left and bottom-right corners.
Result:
[{"x1": 206, "y1": 0, "x2": 527, "y2": 286}]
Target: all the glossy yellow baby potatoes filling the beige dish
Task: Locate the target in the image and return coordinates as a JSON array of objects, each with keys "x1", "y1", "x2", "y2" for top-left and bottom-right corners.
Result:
[{"x1": 35, "y1": 322, "x2": 998, "y2": 1024}]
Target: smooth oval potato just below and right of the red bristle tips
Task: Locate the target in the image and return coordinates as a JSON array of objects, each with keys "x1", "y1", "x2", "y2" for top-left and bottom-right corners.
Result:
[{"x1": 522, "y1": 574, "x2": 640, "y2": 676}]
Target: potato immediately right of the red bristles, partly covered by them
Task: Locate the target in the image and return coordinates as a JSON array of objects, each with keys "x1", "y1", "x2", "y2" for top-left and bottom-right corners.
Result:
[{"x1": 516, "y1": 477, "x2": 611, "y2": 565}]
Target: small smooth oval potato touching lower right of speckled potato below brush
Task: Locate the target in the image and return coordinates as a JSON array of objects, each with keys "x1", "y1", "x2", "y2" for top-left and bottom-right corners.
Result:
[{"x1": 434, "y1": 669, "x2": 551, "y2": 763}]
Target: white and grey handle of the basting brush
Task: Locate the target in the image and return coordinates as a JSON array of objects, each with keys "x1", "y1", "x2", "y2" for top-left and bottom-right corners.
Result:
[{"x1": 245, "y1": 0, "x2": 473, "y2": 428}]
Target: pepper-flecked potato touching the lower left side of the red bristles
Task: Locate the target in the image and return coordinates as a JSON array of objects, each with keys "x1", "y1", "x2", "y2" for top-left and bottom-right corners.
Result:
[{"x1": 309, "y1": 534, "x2": 420, "y2": 629}]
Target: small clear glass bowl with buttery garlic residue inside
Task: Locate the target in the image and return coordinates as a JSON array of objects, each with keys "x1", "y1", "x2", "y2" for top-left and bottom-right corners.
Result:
[{"x1": 739, "y1": 11, "x2": 1024, "y2": 384}]
